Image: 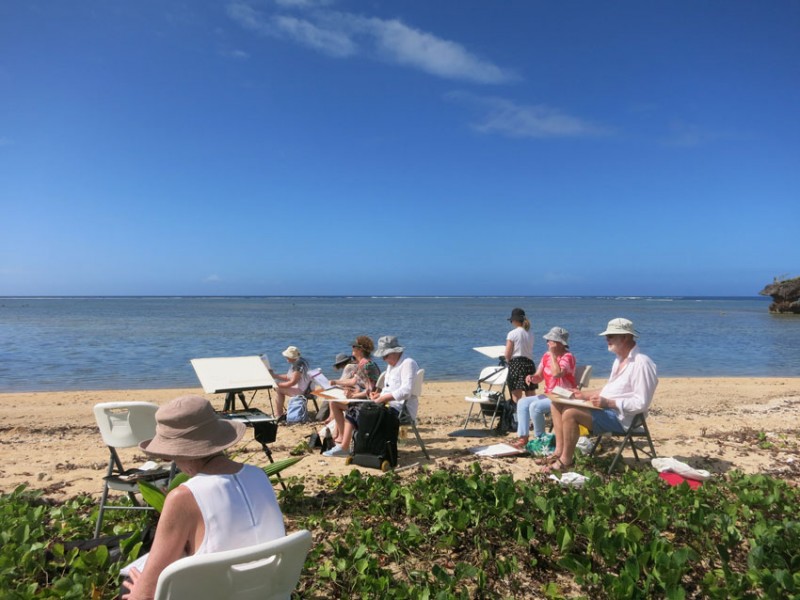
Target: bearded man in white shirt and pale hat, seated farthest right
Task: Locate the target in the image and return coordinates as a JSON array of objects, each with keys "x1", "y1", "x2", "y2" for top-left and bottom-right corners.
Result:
[{"x1": 545, "y1": 318, "x2": 658, "y2": 471}]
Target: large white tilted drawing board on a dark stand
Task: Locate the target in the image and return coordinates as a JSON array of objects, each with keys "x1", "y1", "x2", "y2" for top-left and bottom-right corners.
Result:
[{"x1": 190, "y1": 356, "x2": 275, "y2": 412}]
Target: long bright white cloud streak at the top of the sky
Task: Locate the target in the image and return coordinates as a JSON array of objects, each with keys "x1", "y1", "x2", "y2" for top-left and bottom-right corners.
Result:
[{"x1": 228, "y1": 0, "x2": 518, "y2": 84}]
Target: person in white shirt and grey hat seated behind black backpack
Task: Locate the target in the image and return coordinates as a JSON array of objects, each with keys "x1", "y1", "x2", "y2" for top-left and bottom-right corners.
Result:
[{"x1": 324, "y1": 335, "x2": 419, "y2": 456}]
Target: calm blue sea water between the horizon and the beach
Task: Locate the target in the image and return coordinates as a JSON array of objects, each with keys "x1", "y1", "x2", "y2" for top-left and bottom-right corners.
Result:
[{"x1": 0, "y1": 297, "x2": 800, "y2": 392}]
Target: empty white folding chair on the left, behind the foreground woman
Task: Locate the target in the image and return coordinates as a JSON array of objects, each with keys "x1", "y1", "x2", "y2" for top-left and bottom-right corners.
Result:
[{"x1": 94, "y1": 402, "x2": 169, "y2": 538}]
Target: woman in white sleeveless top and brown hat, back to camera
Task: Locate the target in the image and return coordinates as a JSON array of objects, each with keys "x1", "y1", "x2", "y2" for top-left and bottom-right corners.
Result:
[{"x1": 121, "y1": 396, "x2": 286, "y2": 600}]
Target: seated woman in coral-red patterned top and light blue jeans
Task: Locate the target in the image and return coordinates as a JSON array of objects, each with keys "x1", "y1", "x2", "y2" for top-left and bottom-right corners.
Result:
[{"x1": 514, "y1": 327, "x2": 576, "y2": 451}]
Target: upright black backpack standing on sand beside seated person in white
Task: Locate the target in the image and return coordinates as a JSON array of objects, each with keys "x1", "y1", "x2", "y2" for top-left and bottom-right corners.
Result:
[{"x1": 352, "y1": 402, "x2": 400, "y2": 471}]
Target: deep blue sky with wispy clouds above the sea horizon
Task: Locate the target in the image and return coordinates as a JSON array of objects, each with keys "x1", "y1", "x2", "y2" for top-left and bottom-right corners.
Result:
[{"x1": 0, "y1": 0, "x2": 800, "y2": 295}]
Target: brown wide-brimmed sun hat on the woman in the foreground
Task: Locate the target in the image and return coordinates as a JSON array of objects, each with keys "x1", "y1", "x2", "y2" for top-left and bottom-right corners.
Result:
[{"x1": 139, "y1": 396, "x2": 247, "y2": 458}]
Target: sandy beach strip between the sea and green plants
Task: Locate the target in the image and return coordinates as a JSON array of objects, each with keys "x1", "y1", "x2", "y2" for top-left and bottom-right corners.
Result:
[{"x1": 0, "y1": 378, "x2": 800, "y2": 500}]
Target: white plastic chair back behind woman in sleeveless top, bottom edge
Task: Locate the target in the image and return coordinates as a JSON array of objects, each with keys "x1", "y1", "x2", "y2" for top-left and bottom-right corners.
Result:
[{"x1": 155, "y1": 529, "x2": 311, "y2": 600}]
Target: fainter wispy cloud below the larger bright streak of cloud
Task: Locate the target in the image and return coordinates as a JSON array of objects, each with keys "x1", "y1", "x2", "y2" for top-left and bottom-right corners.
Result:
[{"x1": 447, "y1": 92, "x2": 612, "y2": 138}]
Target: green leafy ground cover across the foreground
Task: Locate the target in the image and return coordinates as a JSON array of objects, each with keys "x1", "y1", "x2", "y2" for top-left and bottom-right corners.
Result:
[{"x1": 0, "y1": 463, "x2": 800, "y2": 599}]
